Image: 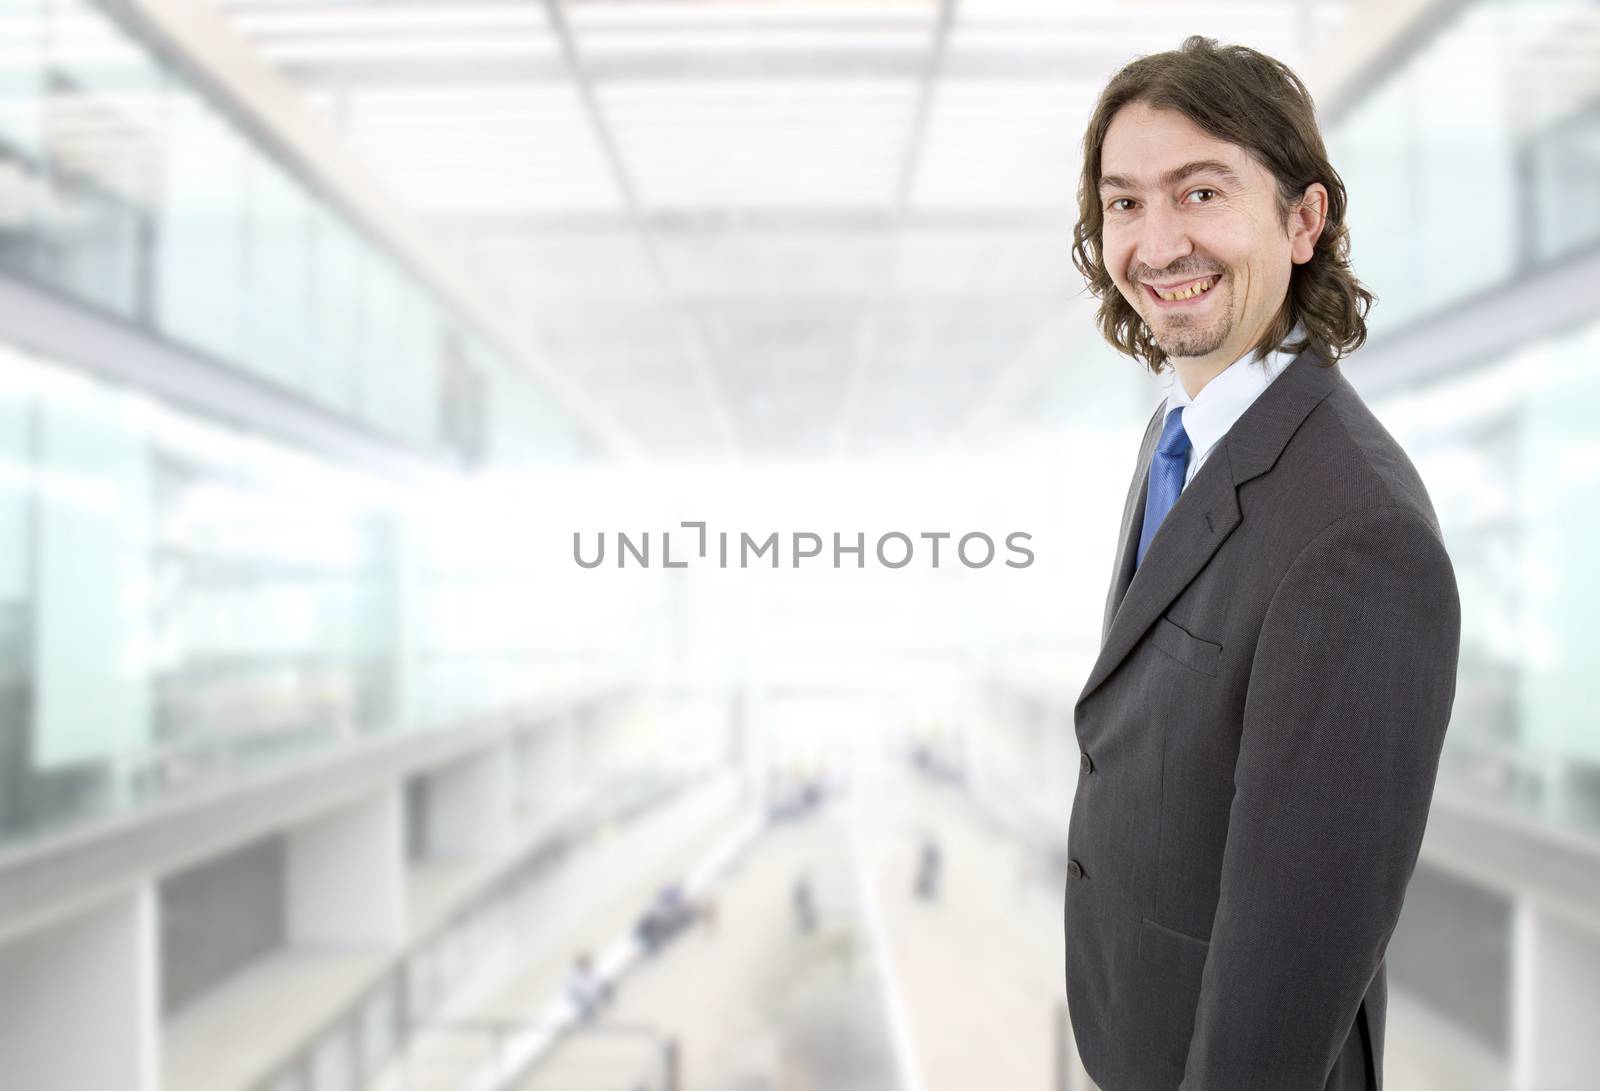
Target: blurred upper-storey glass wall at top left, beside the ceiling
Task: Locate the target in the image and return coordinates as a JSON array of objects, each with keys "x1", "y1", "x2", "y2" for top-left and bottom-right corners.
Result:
[{"x1": 0, "y1": 0, "x2": 584, "y2": 461}]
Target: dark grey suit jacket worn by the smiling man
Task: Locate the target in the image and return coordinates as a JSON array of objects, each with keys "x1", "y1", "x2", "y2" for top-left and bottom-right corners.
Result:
[{"x1": 1064, "y1": 352, "x2": 1461, "y2": 1091}]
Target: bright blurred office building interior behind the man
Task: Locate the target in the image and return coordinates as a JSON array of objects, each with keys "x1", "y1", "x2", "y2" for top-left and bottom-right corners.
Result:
[{"x1": 0, "y1": 0, "x2": 1600, "y2": 1091}]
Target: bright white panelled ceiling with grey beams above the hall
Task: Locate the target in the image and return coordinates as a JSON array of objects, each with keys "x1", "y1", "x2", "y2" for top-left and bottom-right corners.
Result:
[{"x1": 216, "y1": 0, "x2": 1350, "y2": 461}]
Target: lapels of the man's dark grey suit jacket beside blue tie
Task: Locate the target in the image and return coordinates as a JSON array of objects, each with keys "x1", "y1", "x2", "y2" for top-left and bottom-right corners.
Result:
[{"x1": 1078, "y1": 343, "x2": 1342, "y2": 704}]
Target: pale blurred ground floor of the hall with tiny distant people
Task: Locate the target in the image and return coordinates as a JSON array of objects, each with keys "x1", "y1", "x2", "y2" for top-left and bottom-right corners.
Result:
[{"x1": 374, "y1": 769, "x2": 1506, "y2": 1091}]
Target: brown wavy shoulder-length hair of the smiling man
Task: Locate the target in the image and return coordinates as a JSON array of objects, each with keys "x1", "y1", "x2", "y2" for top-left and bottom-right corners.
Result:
[{"x1": 1072, "y1": 35, "x2": 1376, "y2": 373}]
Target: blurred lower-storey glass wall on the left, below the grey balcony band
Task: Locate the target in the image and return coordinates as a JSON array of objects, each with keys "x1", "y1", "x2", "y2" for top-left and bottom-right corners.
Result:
[{"x1": 0, "y1": 342, "x2": 636, "y2": 843}]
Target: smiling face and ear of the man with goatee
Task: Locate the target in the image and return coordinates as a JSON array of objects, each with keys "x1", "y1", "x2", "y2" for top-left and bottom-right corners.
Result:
[{"x1": 1099, "y1": 102, "x2": 1326, "y2": 368}]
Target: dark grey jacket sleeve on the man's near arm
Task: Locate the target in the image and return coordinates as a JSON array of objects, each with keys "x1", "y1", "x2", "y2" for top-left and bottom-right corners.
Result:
[{"x1": 1181, "y1": 507, "x2": 1461, "y2": 1091}]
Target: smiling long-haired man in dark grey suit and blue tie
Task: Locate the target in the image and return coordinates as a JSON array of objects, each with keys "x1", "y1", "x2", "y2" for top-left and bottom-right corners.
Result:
[{"x1": 1066, "y1": 38, "x2": 1461, "y2": 1091}]
